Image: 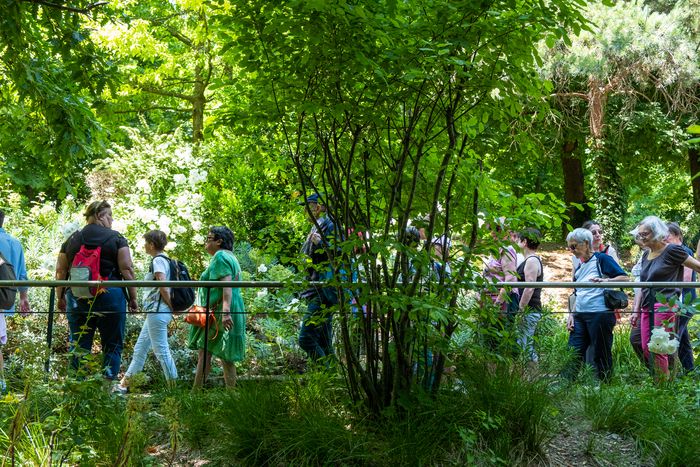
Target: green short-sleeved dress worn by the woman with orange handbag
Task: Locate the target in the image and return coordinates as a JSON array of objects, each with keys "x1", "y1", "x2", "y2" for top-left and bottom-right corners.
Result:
[{"x1": 187, "y1": 250, "x2": 246, "y2": 362}]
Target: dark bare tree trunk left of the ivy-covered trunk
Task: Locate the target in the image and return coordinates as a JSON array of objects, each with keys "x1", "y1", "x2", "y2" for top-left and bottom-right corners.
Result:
[{"x1": 560, "y1": 140, "x2": 591, "y2": 235}]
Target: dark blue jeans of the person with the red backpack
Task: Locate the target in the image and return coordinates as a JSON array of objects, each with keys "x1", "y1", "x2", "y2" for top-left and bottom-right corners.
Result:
[{"x1": 66, "y1": 287, "x2": 126, "y2": 379}]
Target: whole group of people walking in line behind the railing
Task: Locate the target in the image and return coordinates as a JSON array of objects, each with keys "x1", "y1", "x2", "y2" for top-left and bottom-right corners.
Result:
[{"x1": 0, "y1": 198, "x2": 700, "y2": 392}]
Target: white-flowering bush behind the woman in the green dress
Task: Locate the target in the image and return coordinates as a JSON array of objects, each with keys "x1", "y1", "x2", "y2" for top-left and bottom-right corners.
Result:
[{"x1": 88, "y1": 128, "x2": 208, "y2": 274}]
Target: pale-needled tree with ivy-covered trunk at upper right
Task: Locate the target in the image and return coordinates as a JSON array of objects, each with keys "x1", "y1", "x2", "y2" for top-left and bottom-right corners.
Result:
[{"x1": 542, "y1": 0, "x2": 700, "y2": 240}]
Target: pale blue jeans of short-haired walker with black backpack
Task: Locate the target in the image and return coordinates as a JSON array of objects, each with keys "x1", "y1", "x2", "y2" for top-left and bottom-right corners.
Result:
[{"x1": 125, "y1": 303, "x2": 177, "y2": 380}]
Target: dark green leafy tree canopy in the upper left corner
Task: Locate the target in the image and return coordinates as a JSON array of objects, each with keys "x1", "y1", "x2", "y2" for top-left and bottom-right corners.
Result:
[{"x1": 0, "y1": 0, "x2": 113, "y2": 197}]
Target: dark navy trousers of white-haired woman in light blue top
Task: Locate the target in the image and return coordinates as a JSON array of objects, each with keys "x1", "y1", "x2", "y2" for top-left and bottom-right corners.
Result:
[{"x1": 562, "y1": 311, "x2": 616, "y2": 381}]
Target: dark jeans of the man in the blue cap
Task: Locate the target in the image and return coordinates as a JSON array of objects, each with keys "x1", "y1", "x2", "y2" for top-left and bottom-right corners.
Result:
[{"x1": 299, "y1": 287, "x2": 338, "y2": 361}]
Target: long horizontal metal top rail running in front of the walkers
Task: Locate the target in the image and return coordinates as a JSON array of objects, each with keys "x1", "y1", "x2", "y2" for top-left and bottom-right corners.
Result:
[{"x1": 0, "y1": 280, "x2": 700, "y2": 289}]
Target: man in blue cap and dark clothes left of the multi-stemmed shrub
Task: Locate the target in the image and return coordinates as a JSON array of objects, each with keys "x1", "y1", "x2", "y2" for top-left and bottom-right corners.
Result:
[{"x1": 299, "y1": 193, "x2": 338, "y2": 361}]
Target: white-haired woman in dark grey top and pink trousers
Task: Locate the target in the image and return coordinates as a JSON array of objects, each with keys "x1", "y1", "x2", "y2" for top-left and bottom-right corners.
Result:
[{"x1": 630, "y1": 216, "x2": 700, "y2": 374}]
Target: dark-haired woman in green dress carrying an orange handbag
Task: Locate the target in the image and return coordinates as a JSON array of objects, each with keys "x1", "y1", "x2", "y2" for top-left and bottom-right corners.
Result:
[{"x1": 188, "y1": 227, "x2": 246, "y2": 388}]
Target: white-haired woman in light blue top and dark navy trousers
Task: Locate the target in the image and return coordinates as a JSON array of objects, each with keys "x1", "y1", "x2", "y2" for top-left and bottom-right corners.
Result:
[{"x1": 562, "y1": 228, "x2": 627, "y2": 380}]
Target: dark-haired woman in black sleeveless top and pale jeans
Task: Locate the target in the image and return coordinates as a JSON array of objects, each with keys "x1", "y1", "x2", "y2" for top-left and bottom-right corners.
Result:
[{"x1": 517, "y1": 229, "x2": 544, "y2": 362}]
